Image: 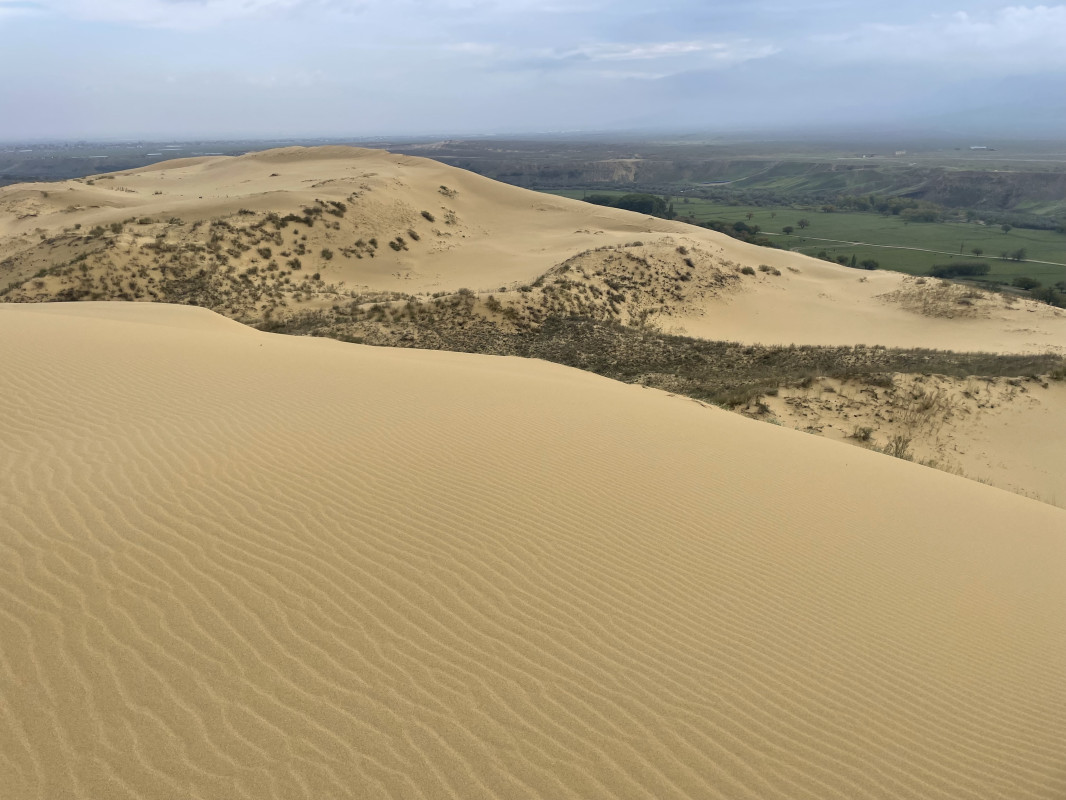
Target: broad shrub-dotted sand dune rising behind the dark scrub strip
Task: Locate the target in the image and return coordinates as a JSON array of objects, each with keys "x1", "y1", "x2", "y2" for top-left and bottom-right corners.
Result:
[{"x1": 0, "y1": 147, "x2": 1066, "y2": 352}]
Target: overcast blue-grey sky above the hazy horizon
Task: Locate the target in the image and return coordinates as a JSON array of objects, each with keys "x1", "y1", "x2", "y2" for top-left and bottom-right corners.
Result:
[{"x1": 0, "y1": 0, "x2": 1066, "y2": 141}]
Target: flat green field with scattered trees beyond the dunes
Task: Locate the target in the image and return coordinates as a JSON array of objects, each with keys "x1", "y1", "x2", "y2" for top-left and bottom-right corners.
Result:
[{"x1": 552, "y1": 189, "x2": 1066, "y2": 286}]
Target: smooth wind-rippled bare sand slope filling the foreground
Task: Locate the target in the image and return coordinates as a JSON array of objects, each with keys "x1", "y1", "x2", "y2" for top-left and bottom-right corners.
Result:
[{"x1": 0, "y1": 303, "x2": 1066, "y2": 800}]
